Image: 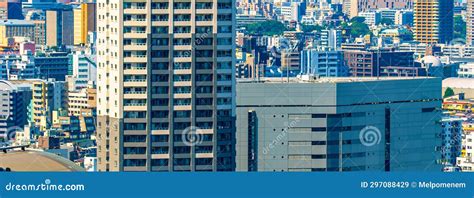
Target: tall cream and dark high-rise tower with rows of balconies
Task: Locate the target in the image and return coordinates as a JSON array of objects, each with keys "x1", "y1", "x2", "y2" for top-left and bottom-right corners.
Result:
[{"x1": 97, "y1": 0, "x2": 235, "y2": 171}]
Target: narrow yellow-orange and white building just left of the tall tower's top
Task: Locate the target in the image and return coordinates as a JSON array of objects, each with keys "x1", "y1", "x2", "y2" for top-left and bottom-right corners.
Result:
[{"x1": 74, "y1": 3, "x2": 96, "y2": 45}]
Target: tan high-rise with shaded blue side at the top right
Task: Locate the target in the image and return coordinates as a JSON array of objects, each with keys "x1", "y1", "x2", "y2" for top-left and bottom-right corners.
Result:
[{"x1": 413, "y1": 0, "x2": 454, "y2": 44}]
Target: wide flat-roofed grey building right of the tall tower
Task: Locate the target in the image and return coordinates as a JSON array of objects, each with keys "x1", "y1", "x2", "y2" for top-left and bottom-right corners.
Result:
[{"x1": 236, "y1": 78, "x2": 442, "y2": 172}]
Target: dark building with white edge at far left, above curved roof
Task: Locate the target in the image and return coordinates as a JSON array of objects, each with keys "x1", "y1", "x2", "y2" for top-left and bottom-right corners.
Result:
[{"x1": 0, "y1": 80, "x2": 31, "y2": 139}]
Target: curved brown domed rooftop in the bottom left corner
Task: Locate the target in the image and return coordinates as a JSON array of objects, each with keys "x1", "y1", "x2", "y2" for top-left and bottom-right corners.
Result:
[{"x1": 0, "y1": 150, "x2": 84, "y2": 172}]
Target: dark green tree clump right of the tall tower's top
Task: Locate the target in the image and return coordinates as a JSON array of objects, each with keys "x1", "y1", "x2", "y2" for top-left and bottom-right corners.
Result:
[{"x1": 245, "y1": 20, "x2": 287, "y2": 36}]
